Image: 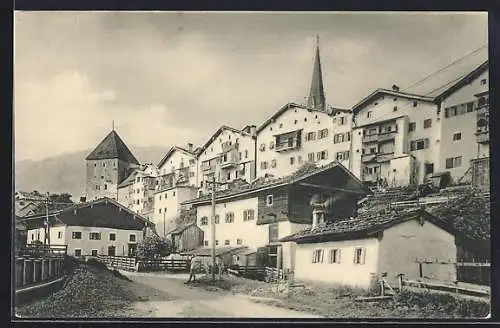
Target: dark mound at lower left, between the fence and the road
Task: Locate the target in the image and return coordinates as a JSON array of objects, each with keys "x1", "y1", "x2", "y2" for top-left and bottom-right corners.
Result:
[{"x1": 16, "y1": 263, "x2": 173, "y2": 319}]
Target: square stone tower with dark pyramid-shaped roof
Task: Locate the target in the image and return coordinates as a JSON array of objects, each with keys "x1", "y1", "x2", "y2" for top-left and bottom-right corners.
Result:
[{"x1": 85, "y1": 129, "x2": 139, "y2": 201}]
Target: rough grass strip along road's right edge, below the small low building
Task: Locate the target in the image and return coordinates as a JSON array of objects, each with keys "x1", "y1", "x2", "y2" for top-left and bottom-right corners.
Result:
[{"x1": 188, "y1": 275, "x2": 490, "y2": 319}]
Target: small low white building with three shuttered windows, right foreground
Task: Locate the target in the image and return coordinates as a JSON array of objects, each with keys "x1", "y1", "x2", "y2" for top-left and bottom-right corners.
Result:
[{"x1": 281, "y1": 210, "x2": 457, "y2": 288}]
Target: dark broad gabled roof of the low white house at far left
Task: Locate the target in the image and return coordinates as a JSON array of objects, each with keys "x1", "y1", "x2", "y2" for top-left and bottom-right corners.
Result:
[{"x1": 18, "y1": 197, "x2": 153, "y2": 230}]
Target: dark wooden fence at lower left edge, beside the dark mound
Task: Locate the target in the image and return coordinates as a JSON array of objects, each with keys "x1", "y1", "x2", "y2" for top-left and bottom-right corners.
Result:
[{"x1": 15, "y1": 254, "x2": 65, "y2": 293}]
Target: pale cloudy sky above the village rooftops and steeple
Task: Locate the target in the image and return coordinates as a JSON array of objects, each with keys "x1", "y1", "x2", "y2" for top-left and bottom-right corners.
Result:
[{"x1": 14, "y1": 11, "x2": 488, "y2": 161}]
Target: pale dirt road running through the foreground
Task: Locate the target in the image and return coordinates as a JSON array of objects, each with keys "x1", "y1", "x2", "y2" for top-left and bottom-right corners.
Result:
[{"x1": 126, "y1": 273, "x2": 319, "y2": 318}]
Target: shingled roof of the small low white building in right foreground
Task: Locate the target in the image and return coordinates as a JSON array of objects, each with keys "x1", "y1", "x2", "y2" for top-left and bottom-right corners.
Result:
[{"x1": 280, "y1": 209, "x2": 458, "y2": 243}]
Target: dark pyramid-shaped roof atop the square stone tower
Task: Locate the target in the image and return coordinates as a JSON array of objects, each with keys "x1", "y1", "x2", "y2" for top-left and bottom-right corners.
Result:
[{"x1": 86, "y1": 129, "x2": 139, "y2": 164}]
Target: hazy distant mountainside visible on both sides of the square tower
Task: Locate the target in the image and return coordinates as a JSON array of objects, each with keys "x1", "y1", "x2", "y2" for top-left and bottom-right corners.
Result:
[{"x1": 14, "y1": 146, "x2": 169, "y2": 200}]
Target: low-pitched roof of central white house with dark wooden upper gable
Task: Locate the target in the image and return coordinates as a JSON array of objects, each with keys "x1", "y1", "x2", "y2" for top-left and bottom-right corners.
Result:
[{"x1": 181, "y1": 161, "x2": 372, "y2": 205}]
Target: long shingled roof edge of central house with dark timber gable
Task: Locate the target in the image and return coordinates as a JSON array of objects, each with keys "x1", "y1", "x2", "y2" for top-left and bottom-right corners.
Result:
[{"x1": 182, "y1": 161, "x2": 372, "y2": 204}]
